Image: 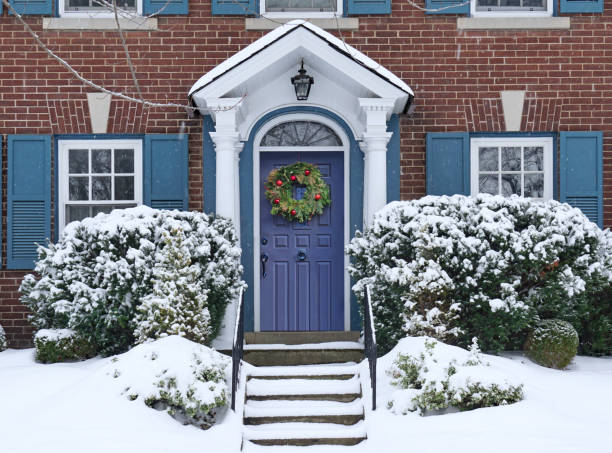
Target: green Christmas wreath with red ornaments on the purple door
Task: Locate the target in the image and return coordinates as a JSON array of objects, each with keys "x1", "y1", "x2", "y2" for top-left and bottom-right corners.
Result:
[{"x1": 265, "y1": 162, "x2": 331, "y2": 222}]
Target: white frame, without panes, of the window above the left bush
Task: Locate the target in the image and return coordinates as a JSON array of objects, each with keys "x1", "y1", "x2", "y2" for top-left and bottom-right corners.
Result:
[{"x1": 56, "y1": 139, "x2": 143, "y2": 234}]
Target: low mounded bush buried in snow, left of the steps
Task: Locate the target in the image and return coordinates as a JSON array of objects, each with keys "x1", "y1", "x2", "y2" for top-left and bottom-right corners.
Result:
[{"x1": 106, "y1": 335, "x2": 231, "y2": 429}]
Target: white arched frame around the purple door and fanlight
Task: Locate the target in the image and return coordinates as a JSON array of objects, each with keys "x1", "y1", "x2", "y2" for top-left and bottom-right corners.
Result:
[{"x1": 252, "y1": 113, "x2": 351, "y2": 332}]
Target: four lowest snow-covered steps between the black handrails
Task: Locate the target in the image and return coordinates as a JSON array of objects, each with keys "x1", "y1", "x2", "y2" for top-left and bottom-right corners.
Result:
[{"x1": 243, "y1": 363, "x2": 366, "y2": 446}]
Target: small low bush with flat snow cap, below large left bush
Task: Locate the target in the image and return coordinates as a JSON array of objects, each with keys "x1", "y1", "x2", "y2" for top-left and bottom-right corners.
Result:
[{"x1": 34, "y1": 329, "x2": 96, "y2": 363}]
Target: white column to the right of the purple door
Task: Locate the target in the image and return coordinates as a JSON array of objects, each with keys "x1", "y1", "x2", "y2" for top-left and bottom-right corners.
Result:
[{"x1": 359, "y1": 98, "x2": 394, "y2": 225}]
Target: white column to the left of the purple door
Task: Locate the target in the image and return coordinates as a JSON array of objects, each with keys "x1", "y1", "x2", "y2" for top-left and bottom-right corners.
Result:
[{"x1": 207, "y1": 98, "x2": 243, "y2": 226}]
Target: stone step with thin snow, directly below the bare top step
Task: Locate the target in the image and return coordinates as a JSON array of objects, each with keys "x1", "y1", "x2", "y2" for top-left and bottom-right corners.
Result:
[{"x1": 243, "y1": 341, "x2": 364, "y2": 366}]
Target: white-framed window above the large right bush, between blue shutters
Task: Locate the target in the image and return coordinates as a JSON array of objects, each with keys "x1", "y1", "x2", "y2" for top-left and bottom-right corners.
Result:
[{"x1": 470, "y1": 137, "x2": 553, "y2": 199}]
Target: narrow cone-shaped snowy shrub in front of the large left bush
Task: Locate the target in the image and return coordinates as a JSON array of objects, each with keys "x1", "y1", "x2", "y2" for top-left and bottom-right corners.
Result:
[{"x1": 134, "y1": 229, "x2": 211, "y2": 344}]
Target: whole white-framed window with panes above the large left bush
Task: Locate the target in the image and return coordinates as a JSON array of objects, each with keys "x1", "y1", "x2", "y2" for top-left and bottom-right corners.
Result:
[{"x1": 58, "y1": 140, "x2": 142, "y2": 230}]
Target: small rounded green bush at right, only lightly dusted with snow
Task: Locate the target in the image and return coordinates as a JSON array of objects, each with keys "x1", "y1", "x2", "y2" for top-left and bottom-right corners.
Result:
[{"x1": 525, "y1": 319, "x2": 578, "y2": 370}]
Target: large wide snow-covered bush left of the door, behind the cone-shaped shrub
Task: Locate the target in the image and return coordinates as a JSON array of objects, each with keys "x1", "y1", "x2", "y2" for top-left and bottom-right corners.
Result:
[{"x1": 20, "y1": 206, "x2": 244, "y2": 355}]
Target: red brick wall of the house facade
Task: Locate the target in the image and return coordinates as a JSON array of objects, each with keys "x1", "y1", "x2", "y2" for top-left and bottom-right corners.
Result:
[{"x1": 0, "y1": 0, "x2": 612, "y2": 347}]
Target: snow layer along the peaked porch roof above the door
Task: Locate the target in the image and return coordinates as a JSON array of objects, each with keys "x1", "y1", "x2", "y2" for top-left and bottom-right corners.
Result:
[{"x1": 189, "y1": 19, "x2": 414, "y2": 97}]
